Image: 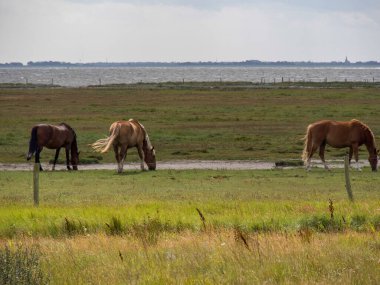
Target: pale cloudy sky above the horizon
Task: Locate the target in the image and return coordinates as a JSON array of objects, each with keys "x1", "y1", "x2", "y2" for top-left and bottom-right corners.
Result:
[{"x1": 0, "y1": 0, "x2": 380, "y2": 63}]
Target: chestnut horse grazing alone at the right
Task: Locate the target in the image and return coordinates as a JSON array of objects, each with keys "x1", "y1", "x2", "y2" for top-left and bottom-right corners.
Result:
[{"x1": 302, "y1": 119, "x2": 378, "y2": 171}]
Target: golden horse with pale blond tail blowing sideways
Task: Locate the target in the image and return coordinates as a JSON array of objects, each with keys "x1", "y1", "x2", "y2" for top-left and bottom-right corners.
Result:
[{"x1": 91, "y1": 119, "x2": 156, "y2": 173}]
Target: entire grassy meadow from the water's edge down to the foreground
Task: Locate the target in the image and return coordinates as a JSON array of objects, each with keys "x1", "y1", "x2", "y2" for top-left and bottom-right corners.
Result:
[{"x1": 0, "y1": 81, "x2": 380, "y2": 284}]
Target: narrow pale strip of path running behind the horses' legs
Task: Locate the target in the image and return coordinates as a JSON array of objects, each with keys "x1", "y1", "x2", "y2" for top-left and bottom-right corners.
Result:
[{"x1": 0, "y1": 160, "x2": 368, "y2": 171}]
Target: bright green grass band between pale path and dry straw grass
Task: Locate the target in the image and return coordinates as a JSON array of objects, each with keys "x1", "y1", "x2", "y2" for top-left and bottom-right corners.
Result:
[{"x1": 0, "y1": 168, "x2": 380, "y2": 238}]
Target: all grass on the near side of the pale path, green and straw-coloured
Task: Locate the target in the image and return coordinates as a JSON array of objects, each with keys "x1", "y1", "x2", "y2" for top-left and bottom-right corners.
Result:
[{"x1": 0, "y1": 168, "x2": 380, "y2": 284}]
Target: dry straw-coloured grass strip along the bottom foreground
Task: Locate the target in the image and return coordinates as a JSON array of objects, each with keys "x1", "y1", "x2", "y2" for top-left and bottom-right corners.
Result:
[{"x1": 2, "y1": 230, "x2": 380, "y2": 284}]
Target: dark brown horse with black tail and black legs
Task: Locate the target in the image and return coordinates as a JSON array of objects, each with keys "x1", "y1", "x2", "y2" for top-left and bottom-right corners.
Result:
[{"x1": 27, "y1": 123, "x2": 79, "y2": 170}]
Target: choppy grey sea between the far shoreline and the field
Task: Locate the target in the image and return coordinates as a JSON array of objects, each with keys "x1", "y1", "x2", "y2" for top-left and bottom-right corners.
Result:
[{"x1": 0, "y1": 66, "x2": 380, "y2": 87}]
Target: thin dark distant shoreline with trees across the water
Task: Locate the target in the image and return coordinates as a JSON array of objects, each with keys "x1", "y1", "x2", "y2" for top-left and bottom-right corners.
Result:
[{"x1": 0, "y1": 60, "x2": 380, "y2": 68}]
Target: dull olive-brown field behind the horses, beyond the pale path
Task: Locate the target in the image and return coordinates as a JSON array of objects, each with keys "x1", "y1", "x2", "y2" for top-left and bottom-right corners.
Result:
[{"x1": 0, "y1": 84, "x2": 380, "y2": 163}]
